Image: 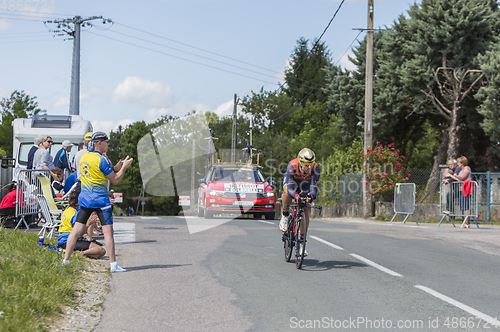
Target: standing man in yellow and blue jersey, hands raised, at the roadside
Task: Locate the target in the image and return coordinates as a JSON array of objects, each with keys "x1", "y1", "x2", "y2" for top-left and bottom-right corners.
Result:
[{"x1": 62, "y1": 132, "x2": 133, "y2": 272}]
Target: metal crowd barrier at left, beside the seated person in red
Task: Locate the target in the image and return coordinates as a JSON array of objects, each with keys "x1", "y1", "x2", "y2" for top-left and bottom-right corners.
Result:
[{"x1": 14, "y1": 169, "x2": 50, "y2": 230}]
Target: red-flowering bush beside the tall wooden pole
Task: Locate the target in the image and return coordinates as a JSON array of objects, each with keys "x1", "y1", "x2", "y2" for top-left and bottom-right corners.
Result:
[{"x1": 360, "y1": 142, "x2": 411, "y2": 194}]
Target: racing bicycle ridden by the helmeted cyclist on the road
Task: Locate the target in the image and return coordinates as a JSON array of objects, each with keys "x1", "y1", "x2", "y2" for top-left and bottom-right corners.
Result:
[{"x1": 282, "y1": 197, "x2": 321, "y2": 269}]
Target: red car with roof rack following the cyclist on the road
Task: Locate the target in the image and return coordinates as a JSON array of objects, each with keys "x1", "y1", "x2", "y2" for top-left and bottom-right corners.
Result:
[{"x1": 198, "y1": 165, "x2": 276, "y2": 220}]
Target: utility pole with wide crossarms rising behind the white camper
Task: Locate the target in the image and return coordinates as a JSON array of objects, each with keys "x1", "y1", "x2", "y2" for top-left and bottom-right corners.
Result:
[{"x1": 44, "y1": 16, "x2": 112, "y2": 115}]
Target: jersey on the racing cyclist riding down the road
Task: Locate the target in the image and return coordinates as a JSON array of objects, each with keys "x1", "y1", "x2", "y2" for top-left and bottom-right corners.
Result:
[{"x1": 283, "y1": 158, "x2": 320, "y2": 199}]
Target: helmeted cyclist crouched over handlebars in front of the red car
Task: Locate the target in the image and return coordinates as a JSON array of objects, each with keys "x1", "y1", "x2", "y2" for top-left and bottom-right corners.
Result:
[{"x1": 279, "y1": 148, "x2": 320, "y2": 256}]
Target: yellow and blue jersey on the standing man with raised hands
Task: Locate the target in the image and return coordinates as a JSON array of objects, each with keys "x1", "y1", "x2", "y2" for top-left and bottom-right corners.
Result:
[{"x1": 78, "y1": 151, "x2": 113, "y2": 208}]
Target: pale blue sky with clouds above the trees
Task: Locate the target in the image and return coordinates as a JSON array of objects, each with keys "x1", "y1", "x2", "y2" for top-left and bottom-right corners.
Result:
[{"x1": 0, "y1": 0, "x2": 420, "y2": 132}]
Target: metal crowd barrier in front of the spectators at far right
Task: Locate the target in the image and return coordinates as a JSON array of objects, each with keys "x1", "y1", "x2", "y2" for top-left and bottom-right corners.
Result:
[{"x1": 438, "y1": 181, "x2": 479, "y2": 228}]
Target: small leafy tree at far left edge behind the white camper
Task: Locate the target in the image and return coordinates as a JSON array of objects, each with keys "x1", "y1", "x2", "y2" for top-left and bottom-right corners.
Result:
[{"x1": 0, "y1": 90, "x2": 47, "y2": 157}]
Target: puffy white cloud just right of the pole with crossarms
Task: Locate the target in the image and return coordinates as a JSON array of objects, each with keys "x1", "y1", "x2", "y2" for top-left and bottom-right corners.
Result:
[{"x1": 111, "y1": 76, "x2": 175, "y2": 108}]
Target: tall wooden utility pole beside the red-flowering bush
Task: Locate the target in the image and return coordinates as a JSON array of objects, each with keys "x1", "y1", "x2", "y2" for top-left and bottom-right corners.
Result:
[{"x1": 363, "y1": 0, "x2": 373, "y2": 218}]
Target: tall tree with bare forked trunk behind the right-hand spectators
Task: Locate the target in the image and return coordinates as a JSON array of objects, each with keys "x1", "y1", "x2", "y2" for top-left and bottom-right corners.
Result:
[{"x1": 404, "y1": 0, "x2": 499, "y2": 163}]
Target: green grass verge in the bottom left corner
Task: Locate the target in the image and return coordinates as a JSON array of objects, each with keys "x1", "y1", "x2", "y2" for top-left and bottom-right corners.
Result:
[{"x1": 0, "y1": 228, "x2": 87, "y2": 331}]
